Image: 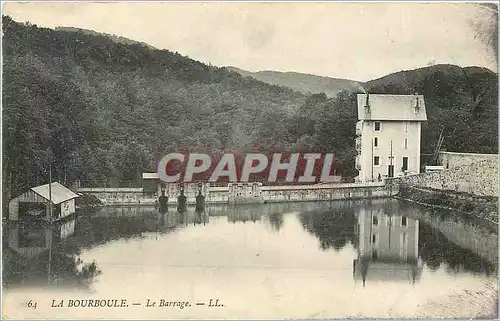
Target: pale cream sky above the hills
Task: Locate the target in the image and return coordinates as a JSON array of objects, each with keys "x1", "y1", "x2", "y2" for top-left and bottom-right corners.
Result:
[{"x1": 3, "y1": 2, "x2": 498, "y2": 81}]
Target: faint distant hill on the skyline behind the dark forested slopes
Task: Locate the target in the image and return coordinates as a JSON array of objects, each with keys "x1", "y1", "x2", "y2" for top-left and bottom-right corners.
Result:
[{"x1": 226, "y1": 67, "x2": 361, "y2": 97}]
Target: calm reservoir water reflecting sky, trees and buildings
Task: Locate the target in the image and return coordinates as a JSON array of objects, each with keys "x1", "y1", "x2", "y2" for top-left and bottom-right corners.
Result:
[{"x1": 3, "y1": 200, "x2": 498, "y2": 319}]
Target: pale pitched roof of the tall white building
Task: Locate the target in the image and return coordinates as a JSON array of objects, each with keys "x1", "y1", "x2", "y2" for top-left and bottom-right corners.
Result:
[{"x1": 358, "y1": 94, "x2": 427, "y2": 121}]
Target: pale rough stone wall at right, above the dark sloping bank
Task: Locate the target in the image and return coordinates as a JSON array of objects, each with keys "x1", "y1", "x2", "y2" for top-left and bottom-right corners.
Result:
[{"x1": 394, "y1": 153, "x2": 499, "y2": 196}]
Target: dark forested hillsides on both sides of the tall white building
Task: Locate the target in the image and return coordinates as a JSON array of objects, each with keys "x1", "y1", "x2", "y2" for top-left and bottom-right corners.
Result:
[{"x1": 2, "y1": 16, "x2": 498, "y2": 200}]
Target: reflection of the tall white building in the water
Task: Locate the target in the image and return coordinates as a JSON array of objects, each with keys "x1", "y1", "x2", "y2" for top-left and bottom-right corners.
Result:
[{"x1": 353, "y1": 200, "x2": 422, "y2": 285}]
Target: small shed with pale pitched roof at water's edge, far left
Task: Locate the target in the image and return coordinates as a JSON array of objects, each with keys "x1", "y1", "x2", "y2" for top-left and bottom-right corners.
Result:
[{"x1": 9, "y1": 182, "x2": 79, "y2": 222}]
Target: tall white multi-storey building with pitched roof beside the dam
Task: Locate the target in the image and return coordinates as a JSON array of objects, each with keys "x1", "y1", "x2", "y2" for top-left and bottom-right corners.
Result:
[{"x1": 356, "y1": 94, "x2": 427, "y2": 182}]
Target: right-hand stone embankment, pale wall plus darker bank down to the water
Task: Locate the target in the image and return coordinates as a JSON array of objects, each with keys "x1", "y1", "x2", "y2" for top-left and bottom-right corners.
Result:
[{"x1": 388, "y1": 152, "x2": 499, "y2": 233}]
